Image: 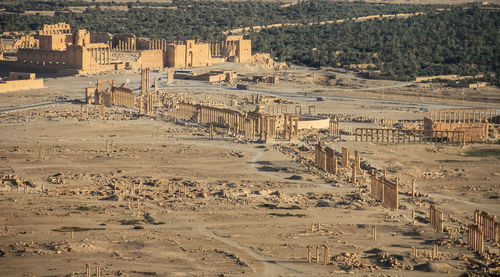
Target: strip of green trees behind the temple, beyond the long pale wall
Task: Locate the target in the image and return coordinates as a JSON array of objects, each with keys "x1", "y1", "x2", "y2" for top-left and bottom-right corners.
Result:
[{"x1": 0, "y1": 0, "x2": 436, "y2": 40}]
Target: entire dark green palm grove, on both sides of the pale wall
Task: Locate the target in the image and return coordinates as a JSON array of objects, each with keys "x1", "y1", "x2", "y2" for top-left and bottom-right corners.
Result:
[{"x1": 0, "y1": 0, "x2": 500, "y2": 85}]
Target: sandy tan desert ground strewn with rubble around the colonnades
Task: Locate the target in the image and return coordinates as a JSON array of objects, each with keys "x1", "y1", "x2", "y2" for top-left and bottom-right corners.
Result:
[{"x1": 0, "y1": 64, "x2": 500, "y2": 276}]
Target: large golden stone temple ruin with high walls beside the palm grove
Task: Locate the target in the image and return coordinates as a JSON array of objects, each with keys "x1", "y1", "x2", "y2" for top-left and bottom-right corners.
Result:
[{"x1": 2, "y1": 23, "x2": 254, "y2": 73}]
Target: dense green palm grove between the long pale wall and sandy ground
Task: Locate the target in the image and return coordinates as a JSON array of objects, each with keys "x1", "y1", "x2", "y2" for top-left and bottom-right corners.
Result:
[{"x1": 250, "y1": 6, "x2": 500, "y2": 85}]
